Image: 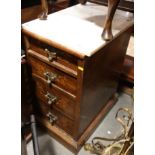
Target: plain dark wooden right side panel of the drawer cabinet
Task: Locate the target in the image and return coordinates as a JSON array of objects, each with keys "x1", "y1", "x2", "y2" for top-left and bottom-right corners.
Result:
[{"x1": 79, "y1": 26, "x2": 133, "y2": 135}]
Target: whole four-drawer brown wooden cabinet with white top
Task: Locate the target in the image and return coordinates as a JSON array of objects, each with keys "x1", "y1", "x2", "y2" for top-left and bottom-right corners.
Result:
[{"x1": 22, "y1": 3, "x2": 133, "y2": 152}]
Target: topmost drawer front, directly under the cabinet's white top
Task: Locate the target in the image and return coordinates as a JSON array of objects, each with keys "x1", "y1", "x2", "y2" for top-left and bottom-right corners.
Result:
[{"x1": 29, "y1": 38, "x2": 77, "y2": 72}]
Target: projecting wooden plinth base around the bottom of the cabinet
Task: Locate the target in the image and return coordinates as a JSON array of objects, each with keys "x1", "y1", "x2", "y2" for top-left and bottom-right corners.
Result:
[{"x1": 39, "y1": 95, "x2": 118, "y2": 154}]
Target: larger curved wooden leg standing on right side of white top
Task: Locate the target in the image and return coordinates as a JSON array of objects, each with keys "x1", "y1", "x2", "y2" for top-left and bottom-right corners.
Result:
[{"x1": 102, "y1": 0, "x2": 120, "y2": 41}]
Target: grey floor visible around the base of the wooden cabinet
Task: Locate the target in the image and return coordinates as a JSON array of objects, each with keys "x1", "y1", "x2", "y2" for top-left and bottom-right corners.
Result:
[{"x1": 27, "y1": 93, "x2": 133, "y2": 155}]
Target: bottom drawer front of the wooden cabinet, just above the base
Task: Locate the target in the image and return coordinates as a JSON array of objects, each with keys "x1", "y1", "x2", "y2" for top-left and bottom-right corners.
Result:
[{"x1": 36, "y1": 101, "x2": 74, "y2": 136}]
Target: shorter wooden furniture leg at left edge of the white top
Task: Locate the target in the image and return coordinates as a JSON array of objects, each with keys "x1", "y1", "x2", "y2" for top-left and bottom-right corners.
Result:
[{"x1": 39, "y1": 0, "x2": 48, "y2": 20}]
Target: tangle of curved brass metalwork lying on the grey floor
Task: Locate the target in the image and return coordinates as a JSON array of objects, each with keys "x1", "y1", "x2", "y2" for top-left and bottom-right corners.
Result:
[{"x1": 84, "y1": 103, "x2": 134, "y2": 155}]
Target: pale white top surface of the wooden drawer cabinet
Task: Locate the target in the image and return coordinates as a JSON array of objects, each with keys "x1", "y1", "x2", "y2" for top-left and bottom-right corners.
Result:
[{"x1": 22, "y1": 2, "x2": 133, "y2": 56}]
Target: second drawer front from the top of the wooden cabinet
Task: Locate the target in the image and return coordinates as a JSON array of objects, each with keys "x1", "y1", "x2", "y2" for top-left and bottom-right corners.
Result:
[{"x1": 28, "y1": 56, "x2": 77, "y2": 95}]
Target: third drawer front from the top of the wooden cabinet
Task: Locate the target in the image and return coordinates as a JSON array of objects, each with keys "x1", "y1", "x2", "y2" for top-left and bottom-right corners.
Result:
[{"x1": 33, "y1": 76, "x2": 75, "y2": 120}]
